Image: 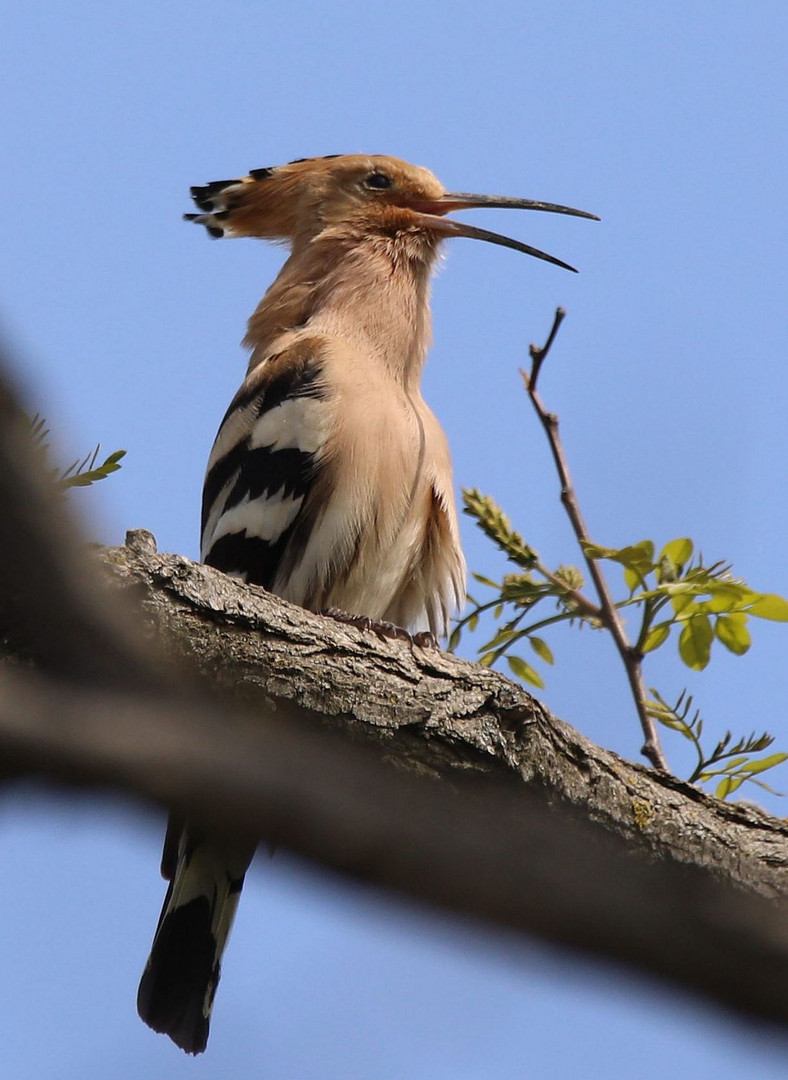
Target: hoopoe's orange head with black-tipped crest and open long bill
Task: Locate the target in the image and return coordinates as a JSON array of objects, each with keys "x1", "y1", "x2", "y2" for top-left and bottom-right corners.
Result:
[{"x1": 185, "y1": 154, "x2": 598, "y2": 270}]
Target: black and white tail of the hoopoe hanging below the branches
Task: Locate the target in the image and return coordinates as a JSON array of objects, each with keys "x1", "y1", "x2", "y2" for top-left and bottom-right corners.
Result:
[{"x1": 137, "y1": 831, "x2": 254, "y2": 1054}]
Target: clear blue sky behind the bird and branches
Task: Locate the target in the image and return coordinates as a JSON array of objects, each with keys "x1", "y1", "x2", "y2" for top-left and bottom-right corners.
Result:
[{"x1": 0, "y1": 0, "x2": 788, "y2": 1080}]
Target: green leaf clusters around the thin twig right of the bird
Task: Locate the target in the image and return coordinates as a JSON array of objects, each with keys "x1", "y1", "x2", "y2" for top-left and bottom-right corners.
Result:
[{"x1": 449, "y1": 468, "x2": 788, "y2": 798}]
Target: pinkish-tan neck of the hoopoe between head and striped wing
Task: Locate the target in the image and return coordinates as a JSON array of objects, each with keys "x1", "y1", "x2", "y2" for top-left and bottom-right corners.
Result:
[{"x1": 244, "y1": 230, "x2": 437, "y2": 387}]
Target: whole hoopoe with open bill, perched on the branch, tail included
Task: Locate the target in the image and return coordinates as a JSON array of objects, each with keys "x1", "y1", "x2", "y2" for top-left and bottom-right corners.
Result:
[{"x1": 138, "y1": 154, "x2": 595, "y2": 1054}]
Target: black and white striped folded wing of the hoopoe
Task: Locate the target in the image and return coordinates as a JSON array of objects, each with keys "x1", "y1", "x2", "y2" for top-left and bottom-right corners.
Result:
[{"x1": 201, "y1": 356, "x2": 330, "y2": 590}]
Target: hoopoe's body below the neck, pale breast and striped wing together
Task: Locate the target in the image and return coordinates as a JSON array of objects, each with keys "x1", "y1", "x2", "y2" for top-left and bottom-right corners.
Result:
[{"x1": 202, "y1": 336, "x2": 464, "y2": 636}]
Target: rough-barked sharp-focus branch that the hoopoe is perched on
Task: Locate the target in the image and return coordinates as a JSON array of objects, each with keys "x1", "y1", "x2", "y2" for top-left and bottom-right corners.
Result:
[{"x1": 105, "y1": 530, "x2": 788, "y2": 897}]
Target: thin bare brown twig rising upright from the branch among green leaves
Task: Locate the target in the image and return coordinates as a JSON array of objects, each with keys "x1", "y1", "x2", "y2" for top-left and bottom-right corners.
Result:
[{"x1": 520, "y1": 308, "x2": 668, "y2": 772}]
